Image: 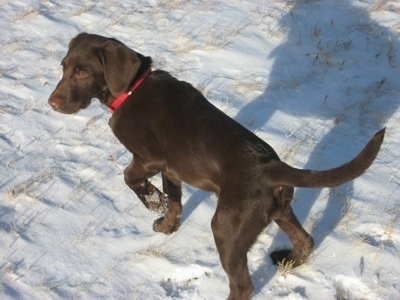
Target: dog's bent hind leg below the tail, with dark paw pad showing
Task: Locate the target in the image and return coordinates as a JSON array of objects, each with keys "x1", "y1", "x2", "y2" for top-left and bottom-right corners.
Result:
[{"x1": 271, "y1": 206, "x2": 314, "y2": 267}]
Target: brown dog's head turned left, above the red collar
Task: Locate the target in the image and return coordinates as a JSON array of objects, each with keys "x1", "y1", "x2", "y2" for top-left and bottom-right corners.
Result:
[{"x1": 48, "y1": 33, "x2": 151, "y2": 114}]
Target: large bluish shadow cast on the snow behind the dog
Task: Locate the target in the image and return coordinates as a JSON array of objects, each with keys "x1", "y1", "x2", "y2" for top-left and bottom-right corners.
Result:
[{"x1": 235, "y1": 1, "x2": 399, "y2": 294}]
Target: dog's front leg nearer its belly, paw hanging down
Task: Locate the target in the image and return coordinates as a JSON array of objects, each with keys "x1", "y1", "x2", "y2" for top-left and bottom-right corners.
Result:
[{"x1": 153, "y1": 173, "x2": 182, "y2": 234}]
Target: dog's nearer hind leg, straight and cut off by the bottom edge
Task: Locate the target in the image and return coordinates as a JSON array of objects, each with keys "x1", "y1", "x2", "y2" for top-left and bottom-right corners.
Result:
[{"x1": 211, "y1": 196, "x2": 267, "y2": 300}]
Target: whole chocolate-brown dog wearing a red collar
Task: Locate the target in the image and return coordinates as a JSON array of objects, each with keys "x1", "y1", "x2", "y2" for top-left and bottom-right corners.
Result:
[{"x1": 49, "y1": 33, "x2": 384, "y2": 299}]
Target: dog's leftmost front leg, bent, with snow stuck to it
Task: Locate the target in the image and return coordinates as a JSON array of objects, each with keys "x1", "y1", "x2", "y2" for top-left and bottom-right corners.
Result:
[{"x1": 124, "y1": 158, "x2": 168, "y2": 213}]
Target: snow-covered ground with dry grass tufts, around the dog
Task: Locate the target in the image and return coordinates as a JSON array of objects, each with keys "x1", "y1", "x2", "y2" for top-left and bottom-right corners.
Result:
[{"x1": 0, "y1": 0, "x2": 400, "y2": 300}]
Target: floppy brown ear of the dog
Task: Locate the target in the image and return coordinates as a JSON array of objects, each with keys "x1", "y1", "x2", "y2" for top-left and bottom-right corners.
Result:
[{"x1": 98, "y1": 40, "x2": 141, "y2": 97}]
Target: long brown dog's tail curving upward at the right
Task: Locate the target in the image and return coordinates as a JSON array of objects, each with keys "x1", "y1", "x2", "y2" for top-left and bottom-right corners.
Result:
[{"x1": 267, "y1": 128, "x2": 386, "y2": 188}]
